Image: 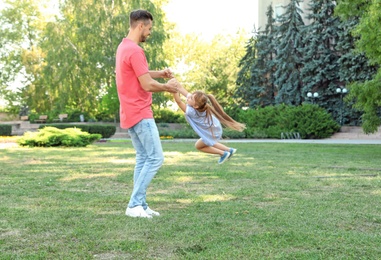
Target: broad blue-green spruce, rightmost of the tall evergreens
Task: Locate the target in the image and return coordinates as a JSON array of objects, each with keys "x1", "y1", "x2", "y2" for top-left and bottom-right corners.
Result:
[{"x1": 302, "y1": 0, "x2": 373, "y2": 124}]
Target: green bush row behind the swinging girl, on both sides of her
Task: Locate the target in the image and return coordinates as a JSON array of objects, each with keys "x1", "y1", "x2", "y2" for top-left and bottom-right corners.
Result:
[{"x1": 158, "y1": 104, "x2": 340, "y2": 139}]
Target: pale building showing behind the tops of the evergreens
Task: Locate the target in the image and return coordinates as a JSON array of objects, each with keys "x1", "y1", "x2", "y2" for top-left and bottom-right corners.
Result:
[{"x1": 257, "y1": 0, "x2": 311, "y2": 29}]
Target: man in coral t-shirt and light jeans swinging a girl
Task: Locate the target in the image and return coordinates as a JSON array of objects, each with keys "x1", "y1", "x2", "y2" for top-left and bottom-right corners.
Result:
[{"x1": 116, "y1": 10, "x2": 177, "y2": 218}]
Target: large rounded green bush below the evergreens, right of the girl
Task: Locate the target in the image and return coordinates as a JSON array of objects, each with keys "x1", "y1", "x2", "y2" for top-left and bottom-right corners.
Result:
[{"x1": 239, "y1": 104, "x2": 340, "y2": 139}]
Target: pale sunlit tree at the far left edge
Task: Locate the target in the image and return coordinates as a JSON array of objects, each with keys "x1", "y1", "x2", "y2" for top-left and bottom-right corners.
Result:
[{"x1": 0, "y1": 0, "x2": 44, "y2": 111}]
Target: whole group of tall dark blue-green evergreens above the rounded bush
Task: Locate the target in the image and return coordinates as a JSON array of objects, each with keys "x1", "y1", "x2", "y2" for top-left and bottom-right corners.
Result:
[{"x1": 236, "y1": 0, "x2": 380, "y2": 128}]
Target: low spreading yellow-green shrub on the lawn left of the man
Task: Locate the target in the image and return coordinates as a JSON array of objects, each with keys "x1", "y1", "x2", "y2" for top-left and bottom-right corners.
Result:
[{"x1": 17, "y1": 127, "x2": 101, "y2": 147}]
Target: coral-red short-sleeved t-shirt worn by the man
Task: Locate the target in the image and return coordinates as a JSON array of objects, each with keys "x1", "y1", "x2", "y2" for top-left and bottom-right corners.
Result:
[{"x1": 115, "y1": 38, "x2": 153, "y2": 128}]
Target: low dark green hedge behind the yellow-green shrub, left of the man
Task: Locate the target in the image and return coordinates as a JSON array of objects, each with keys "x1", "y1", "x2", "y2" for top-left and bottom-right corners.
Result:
[{"x1": 39, "y1": 124, "x2": 116, "y2": 138}]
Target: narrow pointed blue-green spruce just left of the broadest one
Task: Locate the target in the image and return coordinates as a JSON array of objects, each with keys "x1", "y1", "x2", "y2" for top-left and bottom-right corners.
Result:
[{"x1": 274, "y1": 0, "x2": 304, "y2": 105}]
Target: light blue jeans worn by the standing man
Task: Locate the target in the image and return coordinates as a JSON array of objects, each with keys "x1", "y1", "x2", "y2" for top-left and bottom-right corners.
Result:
[{"x1": 128, "y1": 119, "x2": 164, "y2": 209}]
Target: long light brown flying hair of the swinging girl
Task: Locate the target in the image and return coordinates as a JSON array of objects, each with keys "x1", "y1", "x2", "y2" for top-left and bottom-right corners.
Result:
[{"x1": 193, "y1": 91, "x2": 246, "y2": 132}]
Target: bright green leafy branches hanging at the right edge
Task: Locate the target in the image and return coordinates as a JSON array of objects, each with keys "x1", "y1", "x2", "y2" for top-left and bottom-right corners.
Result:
[{"x1": 336, "y1": 0, "x2": 381, "y2": 133}]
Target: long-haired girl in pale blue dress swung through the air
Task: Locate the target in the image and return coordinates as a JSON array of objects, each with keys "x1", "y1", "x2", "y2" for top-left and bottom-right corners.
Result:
[{"x1": 173, "y1": 83, "x2": 245, "y2": 164}]
